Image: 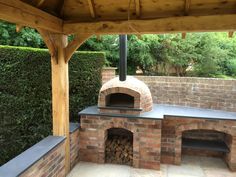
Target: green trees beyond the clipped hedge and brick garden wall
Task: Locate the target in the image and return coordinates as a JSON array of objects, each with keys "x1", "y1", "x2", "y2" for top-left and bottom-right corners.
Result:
[{"x1": 0, "y1": 21, "x2": 236, "y2": 77}]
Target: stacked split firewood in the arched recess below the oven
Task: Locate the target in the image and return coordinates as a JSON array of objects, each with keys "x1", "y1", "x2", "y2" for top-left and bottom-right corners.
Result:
[{"x1": 106, "y1": 135, "x2": 133, "y2": 165}]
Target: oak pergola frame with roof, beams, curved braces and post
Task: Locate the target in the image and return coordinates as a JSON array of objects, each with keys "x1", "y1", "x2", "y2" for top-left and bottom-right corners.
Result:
[{"x1": 0, "y1": 0, "x2": 236, "y2": 175}]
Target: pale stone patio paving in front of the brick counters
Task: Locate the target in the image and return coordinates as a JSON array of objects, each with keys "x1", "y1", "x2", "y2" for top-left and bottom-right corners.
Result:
[{"x1": 67, "y1": 156, "x2": 236, "y2": 177}]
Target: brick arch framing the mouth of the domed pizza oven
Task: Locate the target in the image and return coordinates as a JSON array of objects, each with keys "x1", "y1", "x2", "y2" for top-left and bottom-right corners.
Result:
[{"x1": 98, "y1": 87, "x2": 141, "y2": 108}]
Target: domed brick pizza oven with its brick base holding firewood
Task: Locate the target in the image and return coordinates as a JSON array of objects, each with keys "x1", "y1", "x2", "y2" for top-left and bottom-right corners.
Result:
[{"x1": 80, "y1": 77, "x2": 161, "y2": 169}]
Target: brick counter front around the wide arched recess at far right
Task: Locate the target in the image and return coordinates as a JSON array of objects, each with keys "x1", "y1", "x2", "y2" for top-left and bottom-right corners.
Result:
[{"x1": 161, "y1": 116, "x2": 236, "y2": 171}]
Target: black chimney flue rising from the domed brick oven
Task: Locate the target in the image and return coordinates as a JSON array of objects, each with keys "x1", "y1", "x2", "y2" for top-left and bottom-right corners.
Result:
[{"x1": 119, "y1": 35, "x2": 127, "y2": 81}]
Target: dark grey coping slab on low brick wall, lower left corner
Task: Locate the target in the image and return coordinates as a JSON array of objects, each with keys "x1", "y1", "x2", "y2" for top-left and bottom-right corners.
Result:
[{"x1": 0, "y1": 136, "x2": 66, "y2": 177}]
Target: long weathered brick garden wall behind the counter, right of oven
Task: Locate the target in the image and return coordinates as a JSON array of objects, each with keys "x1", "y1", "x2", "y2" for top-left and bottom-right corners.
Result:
[{"x1": 136, "y1": 76, "x2": 236, "y2": 112}]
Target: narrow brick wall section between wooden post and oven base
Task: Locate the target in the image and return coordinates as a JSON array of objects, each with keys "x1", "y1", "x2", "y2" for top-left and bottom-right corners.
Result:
[{"x1": 70, "y1": 129, "x2": 79, "y2": 169}]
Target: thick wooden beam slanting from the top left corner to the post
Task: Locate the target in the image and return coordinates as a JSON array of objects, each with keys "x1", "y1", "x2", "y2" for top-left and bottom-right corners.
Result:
[{"x1": 0, "y1": 0, "x2": 63, "y2": 33}]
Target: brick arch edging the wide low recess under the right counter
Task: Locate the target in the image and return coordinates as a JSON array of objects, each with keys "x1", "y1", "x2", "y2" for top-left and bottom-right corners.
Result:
[{"x1": 175, "y1": 122, "x2": 235, "y2": 165}]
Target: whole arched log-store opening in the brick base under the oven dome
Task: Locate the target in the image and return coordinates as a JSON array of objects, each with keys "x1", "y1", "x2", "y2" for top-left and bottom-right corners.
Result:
[{"x1": 105, "y1": 128, "x2": 133, "y2": 166}]
